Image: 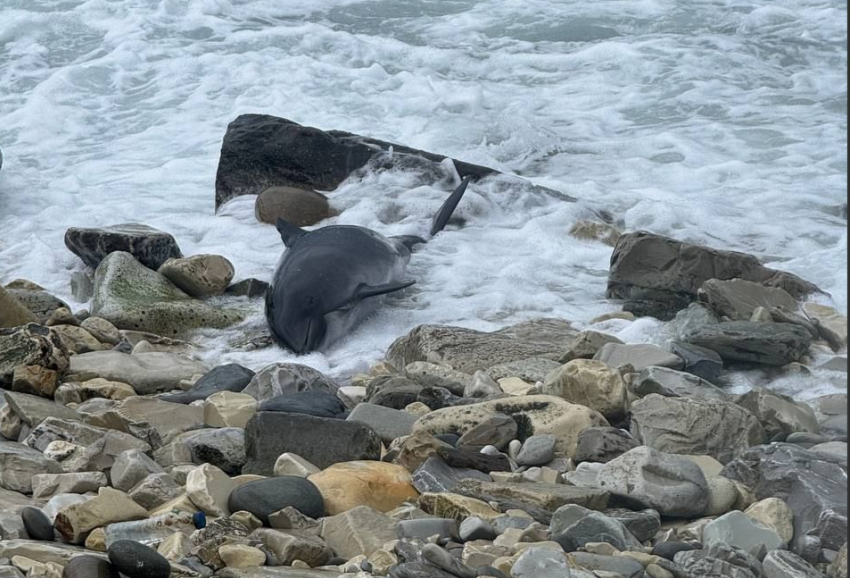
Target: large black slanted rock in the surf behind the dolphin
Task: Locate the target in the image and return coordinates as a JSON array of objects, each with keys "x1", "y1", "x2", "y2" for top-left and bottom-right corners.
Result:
[{"x1": 215, "y1": 114, "x2": 504, "y2": 211}]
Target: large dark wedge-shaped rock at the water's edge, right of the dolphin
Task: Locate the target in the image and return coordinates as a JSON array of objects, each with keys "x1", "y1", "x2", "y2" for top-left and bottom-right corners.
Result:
[{"x1": 606, "y1": 231, "x2": 819, "y2": 321}]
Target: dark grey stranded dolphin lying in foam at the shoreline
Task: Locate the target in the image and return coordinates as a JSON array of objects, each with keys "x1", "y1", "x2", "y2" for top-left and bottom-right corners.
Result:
[{"x1": 266, "y1": 176, "x2": 470, "y2": 354}]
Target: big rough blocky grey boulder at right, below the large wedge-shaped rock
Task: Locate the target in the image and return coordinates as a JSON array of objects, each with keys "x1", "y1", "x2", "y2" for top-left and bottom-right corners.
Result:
[{"x1": 631, "y1": 394, "x2": 766, "y2": 463}]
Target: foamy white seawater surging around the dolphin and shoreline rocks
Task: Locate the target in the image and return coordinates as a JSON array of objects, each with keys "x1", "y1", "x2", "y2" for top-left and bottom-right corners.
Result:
[{"x1": 0, "y1": 0, "x2": 847, "y2": 398}]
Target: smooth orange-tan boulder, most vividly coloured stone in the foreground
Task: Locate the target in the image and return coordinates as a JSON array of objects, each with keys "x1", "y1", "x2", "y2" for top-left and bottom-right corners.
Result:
[{"x1": 308, "y1": 461, "x2": 419, "y2": 516}]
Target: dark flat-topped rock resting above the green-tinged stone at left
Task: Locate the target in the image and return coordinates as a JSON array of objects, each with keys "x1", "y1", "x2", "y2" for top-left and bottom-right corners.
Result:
[{"x1": 65, "y1": 223, "x2": 183, "y2": 270}]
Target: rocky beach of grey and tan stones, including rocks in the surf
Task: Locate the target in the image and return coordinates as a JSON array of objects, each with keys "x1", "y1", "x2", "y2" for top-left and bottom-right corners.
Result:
[{"x1": 0, "y1": 115, "x2": 847, "y2": 578}]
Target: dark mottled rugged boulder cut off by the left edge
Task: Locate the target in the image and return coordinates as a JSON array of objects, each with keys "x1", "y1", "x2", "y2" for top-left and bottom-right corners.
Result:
[{"x1": 0, "y1": 323, "x2": 68, "y2": 389}]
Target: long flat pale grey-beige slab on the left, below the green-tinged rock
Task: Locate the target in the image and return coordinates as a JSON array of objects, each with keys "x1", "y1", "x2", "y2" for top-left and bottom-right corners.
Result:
[{"x1": 68, "y1": 351, "x2": 207, "y2": 395}]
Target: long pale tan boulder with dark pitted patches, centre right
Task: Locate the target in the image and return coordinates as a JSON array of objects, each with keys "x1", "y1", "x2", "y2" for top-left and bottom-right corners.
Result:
[{"x1": 413, "y1": 395, "x2": 608, "y2": 457}]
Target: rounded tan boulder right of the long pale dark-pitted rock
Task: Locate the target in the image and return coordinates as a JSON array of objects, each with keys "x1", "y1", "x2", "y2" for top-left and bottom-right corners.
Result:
[{"x1": 539, "y1": 359, "x2": 628, "y2": 421}]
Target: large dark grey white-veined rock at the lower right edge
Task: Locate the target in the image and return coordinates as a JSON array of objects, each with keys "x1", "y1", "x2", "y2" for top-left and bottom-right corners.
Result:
[{"x1": 721, "y1": 443, "x2": 847, "y2": 554}]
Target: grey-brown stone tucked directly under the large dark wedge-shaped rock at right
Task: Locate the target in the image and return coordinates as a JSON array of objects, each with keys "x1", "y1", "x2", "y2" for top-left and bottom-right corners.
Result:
[{"x1": 697, "y1": 279, "x2": 799, "y2": 321}]
